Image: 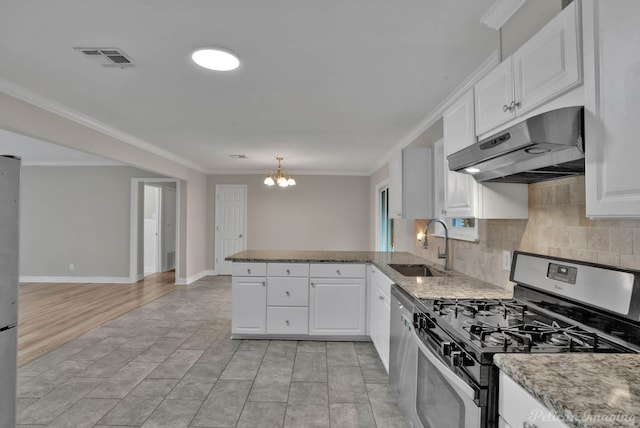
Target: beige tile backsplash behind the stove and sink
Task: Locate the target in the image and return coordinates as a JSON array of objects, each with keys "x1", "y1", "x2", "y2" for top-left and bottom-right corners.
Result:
[{"x1": 414, "y1": 176, "x2": 640, "y2": 288}]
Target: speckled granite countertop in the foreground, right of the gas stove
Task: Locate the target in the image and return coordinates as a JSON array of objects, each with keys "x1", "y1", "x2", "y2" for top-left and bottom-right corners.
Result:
[{"x1": 493, "y1": 353, "x2": 640, "y2": 428}]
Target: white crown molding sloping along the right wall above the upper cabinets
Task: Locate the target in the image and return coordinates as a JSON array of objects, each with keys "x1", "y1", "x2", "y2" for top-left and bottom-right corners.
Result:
[{"x1": 369, "y1": 50, "x2": 500, "y2": 175}]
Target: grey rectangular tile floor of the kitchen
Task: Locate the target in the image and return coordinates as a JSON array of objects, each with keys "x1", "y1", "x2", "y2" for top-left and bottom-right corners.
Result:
[{"x1": 17, "y1": 277, "x2": 405, "y2": 428}]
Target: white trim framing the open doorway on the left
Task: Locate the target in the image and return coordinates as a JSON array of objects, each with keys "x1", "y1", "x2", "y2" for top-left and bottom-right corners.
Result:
[{"x1": 129, "y1": 178, "x2": 184, "y2": 284}]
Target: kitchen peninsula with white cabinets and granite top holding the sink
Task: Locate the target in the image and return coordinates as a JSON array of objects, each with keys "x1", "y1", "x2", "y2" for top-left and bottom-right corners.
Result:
[{"x1": 227, "y1": 250, "x2": 512, "y2": 340}]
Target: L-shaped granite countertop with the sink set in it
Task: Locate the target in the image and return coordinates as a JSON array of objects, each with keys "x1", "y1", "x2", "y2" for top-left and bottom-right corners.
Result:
[{"x1": 227, "y1": 250, "x2": 513, "y2": 299}]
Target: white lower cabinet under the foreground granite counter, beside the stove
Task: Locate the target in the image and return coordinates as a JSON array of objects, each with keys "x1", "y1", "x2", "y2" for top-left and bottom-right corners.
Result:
[{"x1": 498, "y1": 372, "x2": 567, "y2": 428}]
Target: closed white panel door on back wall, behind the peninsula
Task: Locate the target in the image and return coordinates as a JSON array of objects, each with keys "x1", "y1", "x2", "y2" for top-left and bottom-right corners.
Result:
[{"x1": 215, "y1": 184, "x2": 247, "y2": 275}]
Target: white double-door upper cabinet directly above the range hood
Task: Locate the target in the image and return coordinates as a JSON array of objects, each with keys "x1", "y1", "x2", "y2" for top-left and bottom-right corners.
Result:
[{"x1": 474, "y1": 1, "x2": 582, "y2": 135}]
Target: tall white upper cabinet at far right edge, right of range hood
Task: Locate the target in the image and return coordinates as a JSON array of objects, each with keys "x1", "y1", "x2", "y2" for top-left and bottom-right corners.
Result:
[{"x1": 583, "y1": 0, "x2": 640, "y2": 218}]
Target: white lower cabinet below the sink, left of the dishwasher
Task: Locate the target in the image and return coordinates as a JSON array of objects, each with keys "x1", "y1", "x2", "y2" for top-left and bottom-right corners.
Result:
[{"x1": 369, "y1": 266, "x2": 392, "y2": 373}]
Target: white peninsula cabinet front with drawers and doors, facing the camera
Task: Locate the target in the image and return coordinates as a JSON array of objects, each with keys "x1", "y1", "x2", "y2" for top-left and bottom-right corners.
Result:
[{"x1": 231, "y1": 263, "x2": 368, "y2": 338}]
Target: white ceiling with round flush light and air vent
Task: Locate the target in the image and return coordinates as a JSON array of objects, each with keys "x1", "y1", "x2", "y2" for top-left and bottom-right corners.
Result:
[{"x1": 0, "y1": 0, "x2": 498, "y2": 174}]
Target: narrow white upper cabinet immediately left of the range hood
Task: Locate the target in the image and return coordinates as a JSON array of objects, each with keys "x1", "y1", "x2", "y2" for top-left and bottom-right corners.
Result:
[{"x1": 443, "y1": 90, "x2": 478, "y2": 217}]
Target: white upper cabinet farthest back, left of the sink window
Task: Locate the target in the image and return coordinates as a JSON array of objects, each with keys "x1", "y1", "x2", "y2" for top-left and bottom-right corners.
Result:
[{"x1": 389, "y1": 147, "x2": 433, "y2": 219}]
